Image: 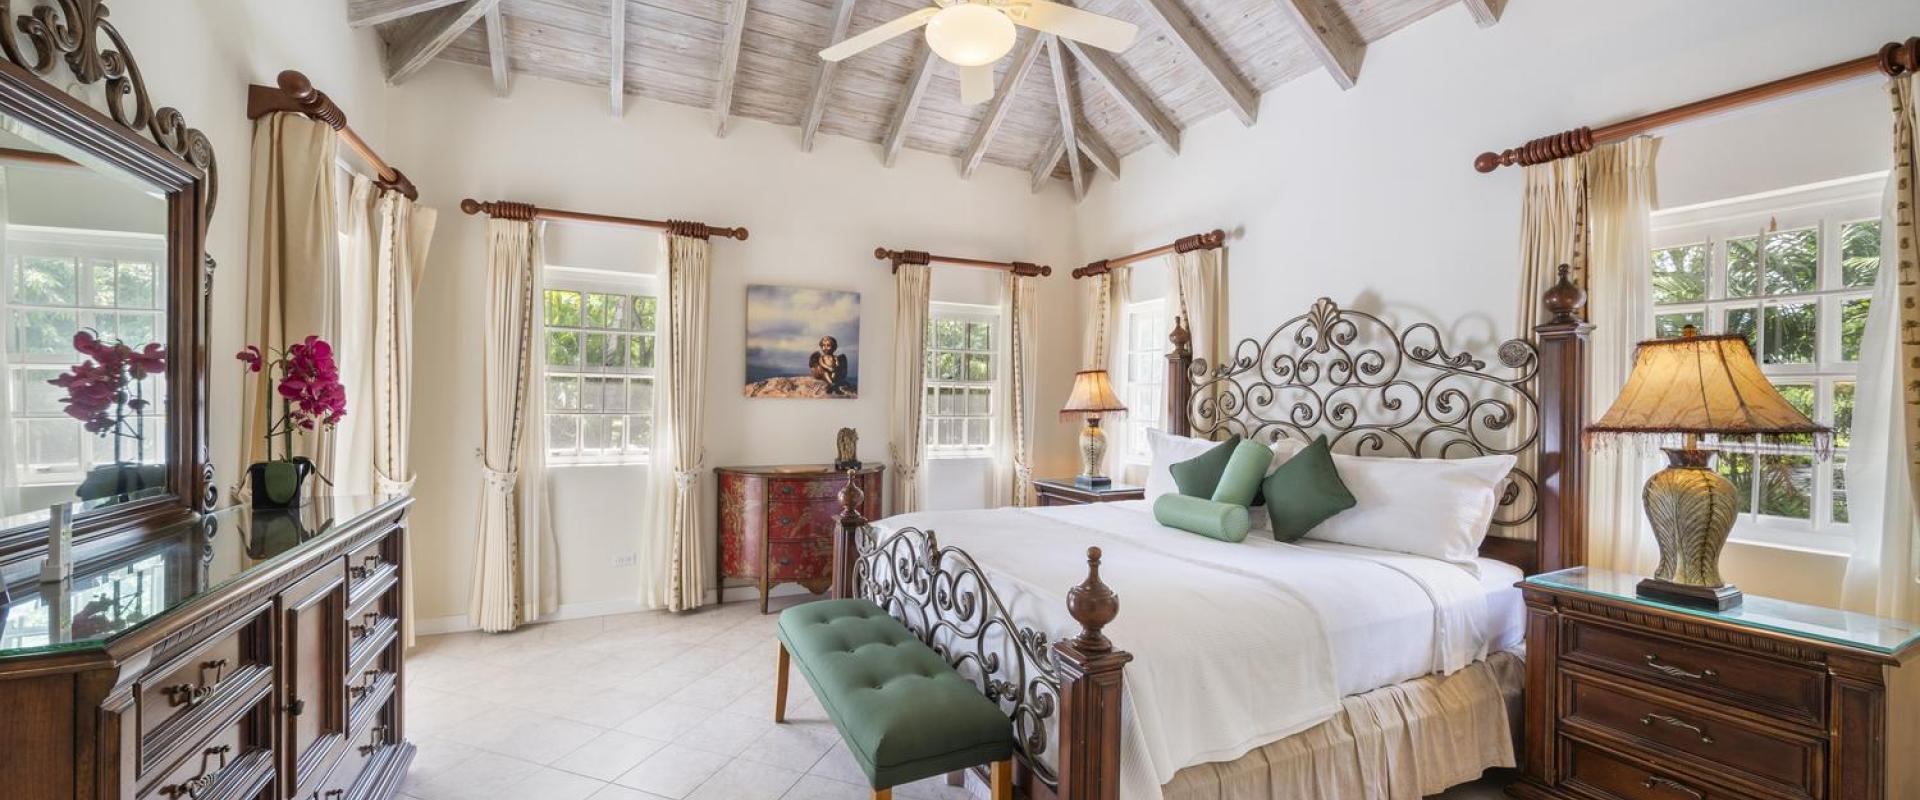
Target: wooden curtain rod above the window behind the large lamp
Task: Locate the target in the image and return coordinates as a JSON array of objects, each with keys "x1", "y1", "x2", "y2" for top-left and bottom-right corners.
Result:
[{"x1": 1473, "y1": 36, "x2": 1920, "y2": 173}]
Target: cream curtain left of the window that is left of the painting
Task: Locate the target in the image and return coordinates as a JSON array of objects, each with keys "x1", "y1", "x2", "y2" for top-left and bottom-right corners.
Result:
[{"x1": 468, "y1": 219, "x2": 557, "y2": 631}]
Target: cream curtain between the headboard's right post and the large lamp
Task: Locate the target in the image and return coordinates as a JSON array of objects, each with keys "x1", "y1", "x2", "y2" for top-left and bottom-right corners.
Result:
[{"x1": 1582, "y1": 136, "x2": 1659, "y2": 574}]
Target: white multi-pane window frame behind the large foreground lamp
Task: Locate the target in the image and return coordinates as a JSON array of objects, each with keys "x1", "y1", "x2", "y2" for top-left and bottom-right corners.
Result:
[{"x1": 1634, "y1": 173, "x2": 1889, "y2": 554}]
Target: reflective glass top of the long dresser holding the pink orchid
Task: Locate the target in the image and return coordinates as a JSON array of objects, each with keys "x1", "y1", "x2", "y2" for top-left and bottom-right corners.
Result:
[{"x1": 0, "y1": 495, "x2": 397, "y2": 658}]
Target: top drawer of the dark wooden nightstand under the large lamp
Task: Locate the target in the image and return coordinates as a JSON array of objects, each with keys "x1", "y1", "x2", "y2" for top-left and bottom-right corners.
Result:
[{"x1": 1561, "y1": 620, "x2": 1826, "y2": 727}]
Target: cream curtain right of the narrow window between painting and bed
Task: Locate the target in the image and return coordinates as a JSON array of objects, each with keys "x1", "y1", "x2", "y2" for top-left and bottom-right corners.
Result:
[{"x1": 998, "y1": 272, "x2": 1039, "y2": 506}]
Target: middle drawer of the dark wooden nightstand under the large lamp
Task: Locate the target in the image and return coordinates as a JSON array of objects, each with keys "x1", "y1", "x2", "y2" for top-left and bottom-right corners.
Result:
[{"x1": 1561, "y1": 673, "x2": 1826, "y2": 798}]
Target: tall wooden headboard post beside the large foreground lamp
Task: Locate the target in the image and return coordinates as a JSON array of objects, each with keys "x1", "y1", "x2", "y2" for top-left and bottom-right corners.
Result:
[{"x1": 1534, "y1": 265, "x2": 1594, "y2": 572}]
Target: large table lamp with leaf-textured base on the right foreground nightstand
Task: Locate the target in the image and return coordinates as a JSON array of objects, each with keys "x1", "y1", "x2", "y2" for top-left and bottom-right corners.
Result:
[{"x1": 1586, "y1": 326, "x2": 1832, "y2": 610}]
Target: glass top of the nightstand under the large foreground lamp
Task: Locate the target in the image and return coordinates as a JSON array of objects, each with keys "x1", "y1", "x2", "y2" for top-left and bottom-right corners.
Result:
[{"x1": 1526, "y1": 566, "x2": 1920, "y2": 654}]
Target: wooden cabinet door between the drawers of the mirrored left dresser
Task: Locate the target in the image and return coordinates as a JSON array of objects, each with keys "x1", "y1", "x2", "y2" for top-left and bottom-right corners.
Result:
[{"x1": 280, "y1": 558, "x2": 348, "y2": 798}]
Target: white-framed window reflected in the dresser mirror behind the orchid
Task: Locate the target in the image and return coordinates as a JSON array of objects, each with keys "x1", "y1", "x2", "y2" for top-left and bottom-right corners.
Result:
[{"x1": 0, "y1": 224, "x2": 167, "y2": 485}]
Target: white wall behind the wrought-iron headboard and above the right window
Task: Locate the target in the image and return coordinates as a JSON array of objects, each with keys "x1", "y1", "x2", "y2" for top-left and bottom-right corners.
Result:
[{"x1": 1077, "y1": 0, "x2": 1920, "y2": 600}]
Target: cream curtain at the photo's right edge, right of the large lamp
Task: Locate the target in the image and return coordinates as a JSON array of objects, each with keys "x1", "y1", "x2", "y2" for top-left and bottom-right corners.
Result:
[{"x1": 1843, "y1": 75, "x2": 1920, "y2": 620}]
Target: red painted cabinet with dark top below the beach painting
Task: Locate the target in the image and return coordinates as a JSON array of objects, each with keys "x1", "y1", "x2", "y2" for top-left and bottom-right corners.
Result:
[{"x1": 714, "y1": 464, "x2": 885, "y2": 614}]
